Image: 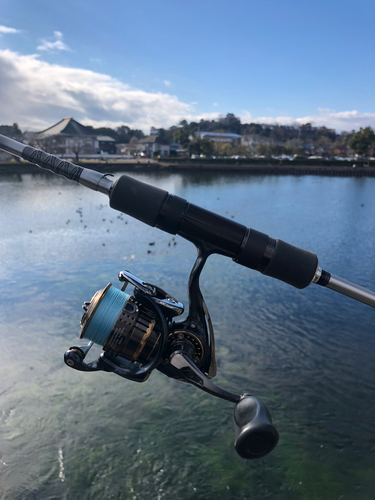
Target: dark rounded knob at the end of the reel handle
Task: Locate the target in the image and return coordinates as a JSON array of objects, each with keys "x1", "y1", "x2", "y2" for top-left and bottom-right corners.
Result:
[{"x1": 234, "y1": 394, "x2": 279, "y2": 459}]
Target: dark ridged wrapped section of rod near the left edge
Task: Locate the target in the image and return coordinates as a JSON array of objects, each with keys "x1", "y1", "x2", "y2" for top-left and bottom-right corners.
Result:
[{"x1": 22, "y1": 146, "x2": 83, "y2": 182}]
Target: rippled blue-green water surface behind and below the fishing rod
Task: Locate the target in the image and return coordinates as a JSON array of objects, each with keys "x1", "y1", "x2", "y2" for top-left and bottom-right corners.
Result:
[{"x1": 0, "y1": 173, "x2": 375, "y2": 500}]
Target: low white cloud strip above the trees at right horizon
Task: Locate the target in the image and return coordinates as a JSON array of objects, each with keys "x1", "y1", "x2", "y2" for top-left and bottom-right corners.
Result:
[{"x1": 239, "y1": 108, "x2": 375, "y2": 132}]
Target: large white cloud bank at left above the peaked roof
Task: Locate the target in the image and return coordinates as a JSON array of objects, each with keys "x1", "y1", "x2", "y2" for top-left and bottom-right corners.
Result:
[{"x1": 0, "y1": 50, "x2": 218, "y2": 132}]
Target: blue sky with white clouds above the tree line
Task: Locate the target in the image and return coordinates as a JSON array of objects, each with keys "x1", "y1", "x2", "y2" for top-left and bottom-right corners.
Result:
[{"x1": 0, "y1": 0, "x2": 375, "y2": 133}]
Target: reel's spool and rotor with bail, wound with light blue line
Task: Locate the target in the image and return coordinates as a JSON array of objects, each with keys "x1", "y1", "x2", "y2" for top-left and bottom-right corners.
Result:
[{"x1": 64, "y1": 271, "x2": 183, "y2": 382}]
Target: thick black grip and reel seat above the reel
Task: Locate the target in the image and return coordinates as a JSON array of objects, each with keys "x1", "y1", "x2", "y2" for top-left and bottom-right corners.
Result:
[{"x1": 110, "y1": 175, "x2": 318, "y2": 288}]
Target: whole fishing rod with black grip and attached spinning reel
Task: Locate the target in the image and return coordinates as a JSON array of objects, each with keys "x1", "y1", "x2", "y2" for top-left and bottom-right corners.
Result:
[{"x1": 0, "y1": 135, "x2": 375, "y2": 459}]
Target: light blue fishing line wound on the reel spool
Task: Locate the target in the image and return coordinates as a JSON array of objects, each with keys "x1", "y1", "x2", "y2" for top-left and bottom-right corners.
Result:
[{"x1": 84, "y1": 285, "x2": 130, "y2": 346}]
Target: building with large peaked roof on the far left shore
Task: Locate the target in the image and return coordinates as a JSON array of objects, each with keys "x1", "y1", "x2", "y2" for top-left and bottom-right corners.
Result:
[{"x1": 33, "y1": 118, "x2": 116, "y2": 158}]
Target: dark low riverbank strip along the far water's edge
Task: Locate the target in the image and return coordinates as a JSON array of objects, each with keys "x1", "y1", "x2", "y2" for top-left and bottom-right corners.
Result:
[{"x1": 0, "y1": 159, "x2": 375, "y2": 177}]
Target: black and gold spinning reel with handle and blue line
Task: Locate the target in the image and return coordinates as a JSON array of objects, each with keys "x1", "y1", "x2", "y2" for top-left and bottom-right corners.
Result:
[{"x1": 64, "y1": 245, "x2": 279, "y2": 458}]
